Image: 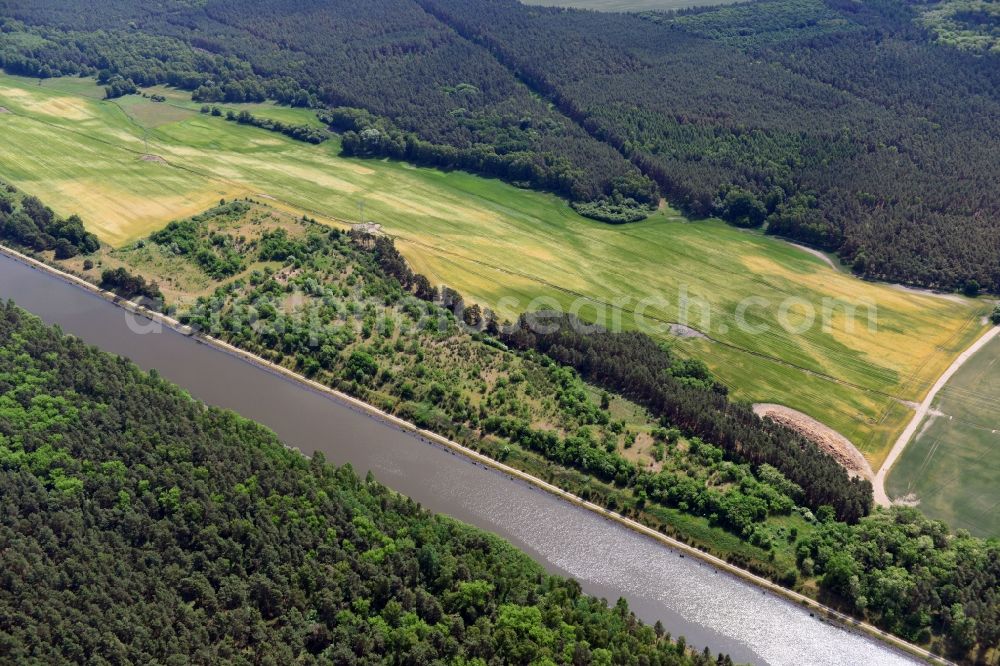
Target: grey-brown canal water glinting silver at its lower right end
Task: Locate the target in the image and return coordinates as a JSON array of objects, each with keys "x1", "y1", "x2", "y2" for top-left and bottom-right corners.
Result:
[{"x1": 0, "y1": 255, "x2": 917, "y2": 666}]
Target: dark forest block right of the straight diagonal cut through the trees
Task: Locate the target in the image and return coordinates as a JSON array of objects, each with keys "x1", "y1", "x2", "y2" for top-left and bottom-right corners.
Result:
[{"x1": 420, "y1": 0, "x2": 1000, "y2": 292}]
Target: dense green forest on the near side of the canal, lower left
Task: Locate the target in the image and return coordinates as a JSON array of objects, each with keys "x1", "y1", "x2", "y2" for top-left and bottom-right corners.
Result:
[{"x1": 0, "y1": 303, "x2": 730, "y2": 665}]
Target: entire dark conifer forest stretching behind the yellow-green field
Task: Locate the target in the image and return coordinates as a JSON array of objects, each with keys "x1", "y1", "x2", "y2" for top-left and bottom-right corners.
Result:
[{"x1": 0, "y1": 0, "x2": 1000, "y2": 293}]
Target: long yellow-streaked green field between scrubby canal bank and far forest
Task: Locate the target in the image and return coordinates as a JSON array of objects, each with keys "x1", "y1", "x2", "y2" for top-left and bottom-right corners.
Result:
[{"x1": 0, "y1": 71, "x2": 986, "y2": 467}]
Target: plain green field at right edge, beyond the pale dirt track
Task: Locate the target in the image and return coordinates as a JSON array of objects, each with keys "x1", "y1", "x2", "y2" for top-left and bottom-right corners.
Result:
[{"x1": 887, "y1": 338, "x2": 1000, "y2": 537}]
